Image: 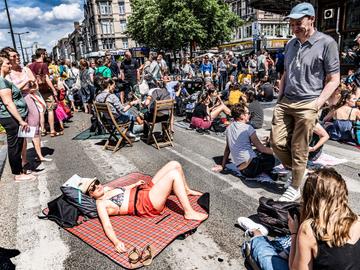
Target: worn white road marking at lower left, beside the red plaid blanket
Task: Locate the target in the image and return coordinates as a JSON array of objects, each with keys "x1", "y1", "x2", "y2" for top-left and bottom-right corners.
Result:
[{"x1": 14, "y1": 163, "x2": 69, "y2": 270}]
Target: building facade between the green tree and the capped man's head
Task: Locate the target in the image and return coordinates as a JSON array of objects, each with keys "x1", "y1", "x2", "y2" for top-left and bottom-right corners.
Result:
[{"x1": 219, "y1": 0, "x2": 292, "y2": 54}]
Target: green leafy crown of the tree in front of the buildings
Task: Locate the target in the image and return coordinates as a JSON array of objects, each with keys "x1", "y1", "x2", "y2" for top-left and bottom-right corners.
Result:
[{"x1": 127, "y1": 0, "x2": 241, "y2": 50}]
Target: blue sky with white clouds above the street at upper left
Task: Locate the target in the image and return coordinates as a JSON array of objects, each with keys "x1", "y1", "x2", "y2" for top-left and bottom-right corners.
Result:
[{"x1": 0, "y1": 0, "x2": 84, "y2": 55}]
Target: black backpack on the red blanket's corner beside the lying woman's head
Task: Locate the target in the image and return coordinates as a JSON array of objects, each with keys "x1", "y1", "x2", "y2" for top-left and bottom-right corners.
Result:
[{"x1": 39, "y1": 195, "x2": 79, "y2": 228}]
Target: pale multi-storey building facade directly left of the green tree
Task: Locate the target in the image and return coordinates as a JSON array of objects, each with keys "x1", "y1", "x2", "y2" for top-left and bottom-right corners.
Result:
[{"x1": 82, "y1": 0, "x2": 135, "y2": 57}]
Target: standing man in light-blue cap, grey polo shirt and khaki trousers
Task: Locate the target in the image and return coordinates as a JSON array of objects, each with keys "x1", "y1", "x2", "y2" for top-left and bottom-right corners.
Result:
[{"x1": 271, "y1": 3, "x2": 340, "y2": 201}]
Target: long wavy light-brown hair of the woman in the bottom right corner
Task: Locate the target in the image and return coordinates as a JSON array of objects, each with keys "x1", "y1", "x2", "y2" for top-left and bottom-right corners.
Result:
[{"x1": 301, "y1": 168, "x2": 358, "y2": 247}]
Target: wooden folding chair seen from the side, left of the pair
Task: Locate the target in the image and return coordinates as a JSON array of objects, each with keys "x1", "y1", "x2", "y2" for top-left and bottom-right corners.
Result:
[{"x1": 94, "y1": 102, "x2": 132, "y2": 152}]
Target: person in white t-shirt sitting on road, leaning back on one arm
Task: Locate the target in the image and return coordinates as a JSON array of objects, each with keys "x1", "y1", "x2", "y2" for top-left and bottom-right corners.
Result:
[{"x1": 213, "y1": 104, "x2": 275, "y2": 178}]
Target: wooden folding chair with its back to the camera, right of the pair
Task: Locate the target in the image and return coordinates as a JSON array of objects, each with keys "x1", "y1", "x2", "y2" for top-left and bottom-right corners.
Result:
[{"x1": 147, "y1": 99, "x2": 174, "y2": 150}]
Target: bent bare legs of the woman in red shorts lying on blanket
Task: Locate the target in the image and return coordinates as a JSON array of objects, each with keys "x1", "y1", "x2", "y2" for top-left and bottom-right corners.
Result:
[{"x1": 149, "y1": 162, "x2": 208, "y2": 220}]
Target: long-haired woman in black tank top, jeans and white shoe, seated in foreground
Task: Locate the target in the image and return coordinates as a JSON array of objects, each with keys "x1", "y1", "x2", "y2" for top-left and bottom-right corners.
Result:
[{"x1": 238, "y1": 168, "x2": 360, "y2": 270}]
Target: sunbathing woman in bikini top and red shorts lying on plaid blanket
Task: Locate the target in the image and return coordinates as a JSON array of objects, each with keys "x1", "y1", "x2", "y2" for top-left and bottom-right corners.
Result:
[{"x1": 83, "y1": 161, "x2": 208, "y2": 252}]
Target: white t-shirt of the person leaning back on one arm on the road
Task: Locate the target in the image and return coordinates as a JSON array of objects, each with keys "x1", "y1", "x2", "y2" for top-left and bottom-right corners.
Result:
[{"x1": 225, "y1": 121, "x2": 256, "y2": 166}]
